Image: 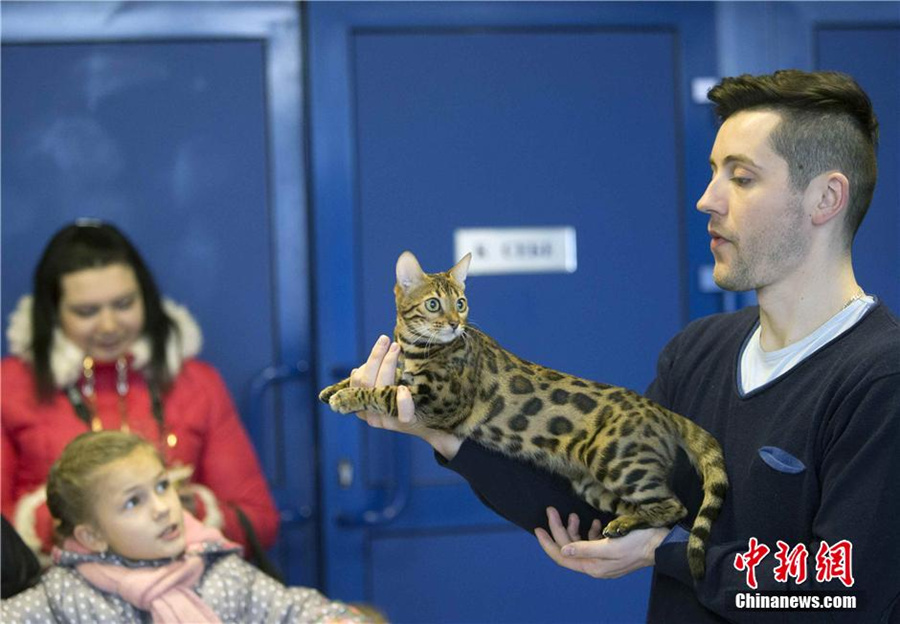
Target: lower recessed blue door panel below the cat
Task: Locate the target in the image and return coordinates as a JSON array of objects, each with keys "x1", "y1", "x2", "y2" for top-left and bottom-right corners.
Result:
[{"x1": 370, "y1": 529, "x2": 649, "y2": 624}]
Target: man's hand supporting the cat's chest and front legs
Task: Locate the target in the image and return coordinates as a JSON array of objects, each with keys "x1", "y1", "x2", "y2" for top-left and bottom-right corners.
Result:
[{"x1": 350, "y1": 336, "x2": 462, "y2": 460}]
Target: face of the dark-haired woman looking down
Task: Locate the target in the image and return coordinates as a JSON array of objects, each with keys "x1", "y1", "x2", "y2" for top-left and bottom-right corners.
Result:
[{"x1": 59, "y1": 264, "x2": 144, "y2": 362}]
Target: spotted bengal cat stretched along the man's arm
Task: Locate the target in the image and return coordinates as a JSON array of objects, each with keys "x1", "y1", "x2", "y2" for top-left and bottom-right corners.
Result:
[{"x1": 319, "y1": 251, "x2": 728, "y2": 579}]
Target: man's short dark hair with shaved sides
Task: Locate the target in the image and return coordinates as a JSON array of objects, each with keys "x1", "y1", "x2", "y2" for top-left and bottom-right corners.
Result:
[{"x1": 708, "y1": 69, "x2": 878, "y2": 247}]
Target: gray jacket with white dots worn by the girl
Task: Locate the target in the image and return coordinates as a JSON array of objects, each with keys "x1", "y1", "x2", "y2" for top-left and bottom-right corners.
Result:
[{"x1": 0, "y1": 543, "x2": 369, "y2": 624}]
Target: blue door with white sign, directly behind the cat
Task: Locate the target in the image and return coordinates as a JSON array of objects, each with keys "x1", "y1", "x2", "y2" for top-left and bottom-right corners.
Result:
[{"x1": 308, "y1": 3, "x2": 714, "y2": 622}]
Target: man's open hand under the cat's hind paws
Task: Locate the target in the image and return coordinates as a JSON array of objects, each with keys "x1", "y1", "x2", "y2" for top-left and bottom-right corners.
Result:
[{"x1": 534, "y1": 507, "x2": 668, "y2": 579}]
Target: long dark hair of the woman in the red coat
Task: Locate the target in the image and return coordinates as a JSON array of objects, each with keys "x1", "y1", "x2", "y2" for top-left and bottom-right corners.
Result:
[{"x1": 31, "y1": 219, "x2": 175, "y2": 399}]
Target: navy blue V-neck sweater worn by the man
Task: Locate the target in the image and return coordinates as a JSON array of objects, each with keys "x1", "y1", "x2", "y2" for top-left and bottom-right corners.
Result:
[{"x1": 441, "y1": 303, "x2": 900, "y2": 623}]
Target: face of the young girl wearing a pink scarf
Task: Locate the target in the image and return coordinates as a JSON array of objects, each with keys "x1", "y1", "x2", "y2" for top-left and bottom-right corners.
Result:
[{"x1": 75, "y1": 447, "x2": 185, "y2": 559}]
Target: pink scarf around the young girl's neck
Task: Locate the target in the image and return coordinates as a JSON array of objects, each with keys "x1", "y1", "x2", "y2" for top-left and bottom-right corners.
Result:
[{"x1": 63, "y1": 512, "x2": 236, "y2": 624}]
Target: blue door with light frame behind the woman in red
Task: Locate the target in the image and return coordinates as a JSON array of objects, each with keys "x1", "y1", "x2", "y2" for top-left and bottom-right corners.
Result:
[{"x1": 2, "y1": 3, "x2": 318, "y2": 585}]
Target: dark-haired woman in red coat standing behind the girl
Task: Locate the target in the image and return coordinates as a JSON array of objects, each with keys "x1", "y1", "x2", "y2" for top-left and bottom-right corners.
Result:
[{"x1": 2, "y1": 220, "x2": 278, "y2": 564}]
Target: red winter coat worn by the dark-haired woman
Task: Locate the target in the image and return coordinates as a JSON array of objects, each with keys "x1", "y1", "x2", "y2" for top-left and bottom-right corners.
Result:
[{"x1": 0, "y1": 357, "x2": 279, "y2": 551}]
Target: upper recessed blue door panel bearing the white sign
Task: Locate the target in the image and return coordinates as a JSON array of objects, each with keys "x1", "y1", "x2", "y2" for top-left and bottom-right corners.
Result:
[{"x1": 353, "y1": 29, "x2": 681, "y2": 480}]
